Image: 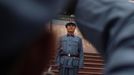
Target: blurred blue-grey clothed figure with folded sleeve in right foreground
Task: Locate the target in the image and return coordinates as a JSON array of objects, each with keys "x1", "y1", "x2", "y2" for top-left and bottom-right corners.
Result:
[{"x1": 76, "y1": 0, "x2": 134, "y2": 75}]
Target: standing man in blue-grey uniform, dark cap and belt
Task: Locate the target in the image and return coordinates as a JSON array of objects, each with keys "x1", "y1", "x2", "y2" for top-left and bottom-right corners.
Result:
[{"x1": 56, "y1": 23, "x2": 84, "y2": 75}]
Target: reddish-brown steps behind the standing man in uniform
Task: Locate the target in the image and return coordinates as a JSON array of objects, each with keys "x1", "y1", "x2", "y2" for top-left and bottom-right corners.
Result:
[{"x1": 51, "y1": 53, "x2": 104, "y2": 75}]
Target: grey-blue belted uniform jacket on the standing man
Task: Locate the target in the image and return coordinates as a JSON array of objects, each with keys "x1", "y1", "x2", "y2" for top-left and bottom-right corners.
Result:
[{"x1": 56, "y1": 35, "x2": 84, "y2": 67}]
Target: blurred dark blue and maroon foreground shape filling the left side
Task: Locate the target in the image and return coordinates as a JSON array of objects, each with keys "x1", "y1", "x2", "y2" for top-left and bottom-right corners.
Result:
[{"x1": 0, "y1": 0, "x2": 68, "y2": 75}]
